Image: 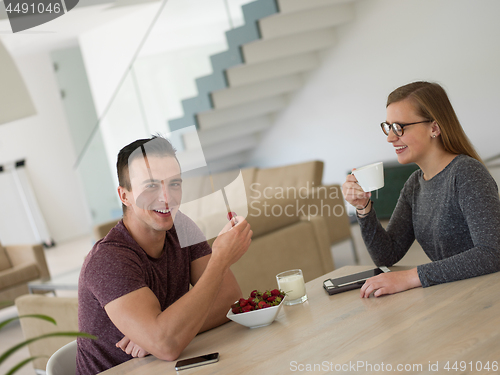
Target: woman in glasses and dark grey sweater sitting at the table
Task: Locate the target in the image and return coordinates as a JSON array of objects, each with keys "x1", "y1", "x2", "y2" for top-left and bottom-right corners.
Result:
[{"x1": 342, "y1": 82, "x2": 500, "y2": 297}]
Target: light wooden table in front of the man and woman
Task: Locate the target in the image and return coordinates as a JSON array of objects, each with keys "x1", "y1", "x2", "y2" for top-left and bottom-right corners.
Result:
[{"x1": 104, "y1": 266, "x2": 500, "y2": 375}]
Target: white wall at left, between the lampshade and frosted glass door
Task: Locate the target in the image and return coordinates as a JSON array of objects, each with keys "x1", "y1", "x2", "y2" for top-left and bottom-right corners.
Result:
[{"x1": 0, "y1": 52, "x2": 90, "y2": 242}]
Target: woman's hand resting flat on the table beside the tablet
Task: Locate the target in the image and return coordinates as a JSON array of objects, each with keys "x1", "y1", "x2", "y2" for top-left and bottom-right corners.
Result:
[{"x1": 361, "y1": 268, "x2": 422, "y2": 298}]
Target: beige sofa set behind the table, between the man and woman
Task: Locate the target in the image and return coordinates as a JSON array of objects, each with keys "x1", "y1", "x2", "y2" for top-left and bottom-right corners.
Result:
[{"x1": 94, "y1": 161, "x2": 357, "y2": 295}]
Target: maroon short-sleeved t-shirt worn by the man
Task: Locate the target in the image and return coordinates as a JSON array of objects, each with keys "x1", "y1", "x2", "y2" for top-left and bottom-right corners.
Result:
[{"x1": 76, "y1": 212, "x2": 212, "y2": 375}]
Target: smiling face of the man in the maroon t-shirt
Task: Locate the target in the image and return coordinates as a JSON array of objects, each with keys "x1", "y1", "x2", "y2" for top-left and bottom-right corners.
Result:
[{"x1": 119, "y1": 156, "x2": 182, "y2": 232}]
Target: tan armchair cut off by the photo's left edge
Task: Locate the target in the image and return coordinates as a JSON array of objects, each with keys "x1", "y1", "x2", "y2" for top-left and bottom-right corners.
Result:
[{"x1": 0, "y1": 244, "x2": 50, "y2": 307}]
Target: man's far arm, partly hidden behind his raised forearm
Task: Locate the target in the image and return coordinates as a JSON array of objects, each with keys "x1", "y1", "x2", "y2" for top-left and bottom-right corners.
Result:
[{"x1": 191, "y1": 255, "x2": 243, "y2": 332}]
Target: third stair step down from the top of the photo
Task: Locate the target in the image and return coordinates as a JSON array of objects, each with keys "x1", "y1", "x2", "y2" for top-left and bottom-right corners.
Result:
[{"x1": 242, "y1": 28, "x2": 336, "y2": 64}]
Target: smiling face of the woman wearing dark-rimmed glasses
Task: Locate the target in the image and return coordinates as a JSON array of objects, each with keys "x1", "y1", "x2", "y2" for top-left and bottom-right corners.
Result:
[{"x1": 386, "y1": 99, "x2": 439, "y2": 166}]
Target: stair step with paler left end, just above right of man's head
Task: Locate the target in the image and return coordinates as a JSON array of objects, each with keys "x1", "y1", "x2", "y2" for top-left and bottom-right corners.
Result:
[{"x1": 183, "y1": 116, "x2": 272, "y2": 149}]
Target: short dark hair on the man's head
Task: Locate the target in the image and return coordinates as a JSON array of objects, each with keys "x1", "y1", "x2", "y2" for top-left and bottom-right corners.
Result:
[{"x1": 116, "y1": 135, "x2": 179, "y2": 212}]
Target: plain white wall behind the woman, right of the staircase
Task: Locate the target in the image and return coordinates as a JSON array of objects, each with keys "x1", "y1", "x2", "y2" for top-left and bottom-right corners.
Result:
[{"x1": 251, "y1": 0, "x2": 500, "y2": 183}]
